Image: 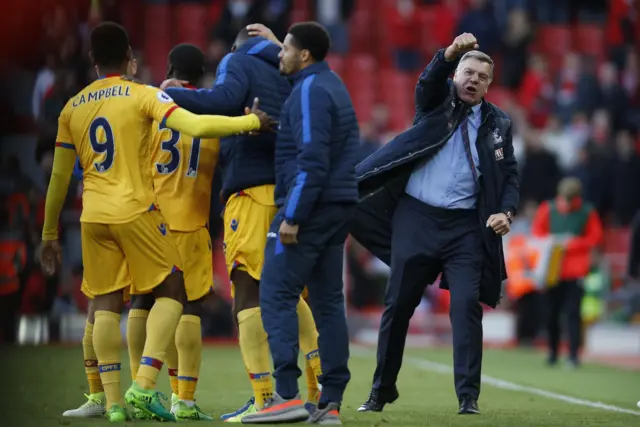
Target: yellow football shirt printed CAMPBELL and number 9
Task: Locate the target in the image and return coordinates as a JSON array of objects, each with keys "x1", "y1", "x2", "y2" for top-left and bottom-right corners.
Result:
[{"x1": 56, "y1": 76, "x2": 178, "y2": 224}]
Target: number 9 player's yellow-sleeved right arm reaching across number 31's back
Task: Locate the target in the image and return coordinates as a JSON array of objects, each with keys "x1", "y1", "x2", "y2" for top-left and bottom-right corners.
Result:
[{"x1": 166, "y1": 104, "x2": 271, "y2": 138}]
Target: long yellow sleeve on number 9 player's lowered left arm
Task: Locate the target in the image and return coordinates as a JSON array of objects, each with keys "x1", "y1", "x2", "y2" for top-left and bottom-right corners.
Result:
[{"x1": 42, "y1": 146, "x2": 76, "y2": 241}]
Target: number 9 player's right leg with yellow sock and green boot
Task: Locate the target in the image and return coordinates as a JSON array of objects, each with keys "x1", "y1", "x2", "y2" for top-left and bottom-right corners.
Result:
[{"x1": 125, "y1": 270, "x2": 187, "y2": 421}]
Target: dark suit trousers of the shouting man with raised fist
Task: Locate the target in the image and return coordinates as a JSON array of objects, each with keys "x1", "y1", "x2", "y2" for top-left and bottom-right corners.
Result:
[{"x1": 373, "y1": 196, "x2": 483, "y2": 399}]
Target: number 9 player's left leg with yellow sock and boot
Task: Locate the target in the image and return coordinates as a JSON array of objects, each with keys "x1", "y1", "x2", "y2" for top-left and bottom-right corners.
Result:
[{"x1": 93, "y1": 290, "x2": 129, "y2": 422}]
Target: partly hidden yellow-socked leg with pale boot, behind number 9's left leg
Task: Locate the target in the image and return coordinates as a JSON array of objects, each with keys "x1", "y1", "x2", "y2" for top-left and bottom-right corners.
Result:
[{"x1": 62, "y1": 299, "x2": 105, "y2": 418}]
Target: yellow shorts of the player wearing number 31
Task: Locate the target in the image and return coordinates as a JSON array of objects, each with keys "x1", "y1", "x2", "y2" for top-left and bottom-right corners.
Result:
[{"x1": 172, "y1": 227, "x2": 213, "y2": 301}]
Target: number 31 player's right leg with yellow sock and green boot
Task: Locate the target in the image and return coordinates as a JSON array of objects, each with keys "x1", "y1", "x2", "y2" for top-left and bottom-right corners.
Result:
[{"x1": 171, "y1": 295, "x2": 213, "y2": 421}]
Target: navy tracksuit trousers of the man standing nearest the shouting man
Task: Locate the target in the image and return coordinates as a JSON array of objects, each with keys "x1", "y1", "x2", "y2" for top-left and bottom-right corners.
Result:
[{"x1": 260, "y1": 205, "x2": 353, "y2": 403}]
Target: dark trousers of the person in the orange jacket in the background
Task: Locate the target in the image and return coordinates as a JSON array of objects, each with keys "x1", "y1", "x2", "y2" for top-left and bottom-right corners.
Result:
[{"x1": 547, "y1": 280, "x2": 584, "y2": 360}]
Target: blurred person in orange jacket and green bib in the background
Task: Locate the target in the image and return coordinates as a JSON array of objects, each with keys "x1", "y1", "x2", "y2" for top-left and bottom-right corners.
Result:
[{"x1": 531, "y1": 178, "x2": 602, "y2": 367}]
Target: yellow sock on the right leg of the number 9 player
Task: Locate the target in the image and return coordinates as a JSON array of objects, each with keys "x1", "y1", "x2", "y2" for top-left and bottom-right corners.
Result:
[{"x1": 136, "y1": 298, "x2": 182, "y2": 390}]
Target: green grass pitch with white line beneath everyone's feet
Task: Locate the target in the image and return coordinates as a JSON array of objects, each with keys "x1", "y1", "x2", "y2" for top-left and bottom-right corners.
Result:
[{"x1": 0, "y1": 346, "x2": 640, "y2": 427}]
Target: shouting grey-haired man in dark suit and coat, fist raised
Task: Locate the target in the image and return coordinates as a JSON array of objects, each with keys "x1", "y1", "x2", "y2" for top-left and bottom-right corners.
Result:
[{"x1": 350, "y1": 33, "x2": 519, "y2": 414}]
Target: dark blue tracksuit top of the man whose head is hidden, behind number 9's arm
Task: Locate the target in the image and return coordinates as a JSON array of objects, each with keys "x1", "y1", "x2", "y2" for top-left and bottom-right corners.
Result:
[{"x1": 167, "y1": 37, "x2": 291, "y2": 200}]
